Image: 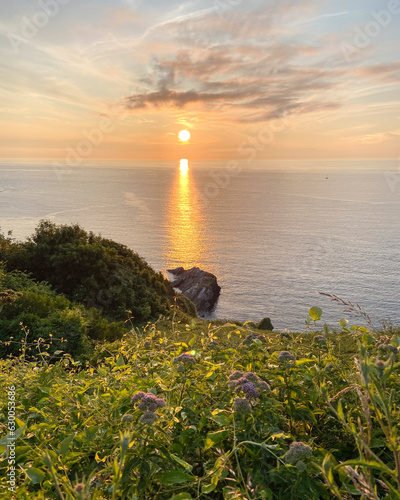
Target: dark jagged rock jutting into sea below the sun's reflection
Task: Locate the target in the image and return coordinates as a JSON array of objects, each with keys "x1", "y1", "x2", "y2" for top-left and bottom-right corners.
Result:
[{"x1": 168, "y1": 267, "x2": 221, "y2": 316}]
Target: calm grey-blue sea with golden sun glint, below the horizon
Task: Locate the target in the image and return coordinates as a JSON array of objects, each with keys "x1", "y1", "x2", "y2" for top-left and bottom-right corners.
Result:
[{"x1": 0, "y1": 159, "x2": 400, "y2": 329}]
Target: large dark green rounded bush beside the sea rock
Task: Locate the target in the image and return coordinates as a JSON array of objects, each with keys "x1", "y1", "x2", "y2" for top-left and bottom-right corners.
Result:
[{"x1": 0, "y1": 221, "x2": 195, "y2": 323}]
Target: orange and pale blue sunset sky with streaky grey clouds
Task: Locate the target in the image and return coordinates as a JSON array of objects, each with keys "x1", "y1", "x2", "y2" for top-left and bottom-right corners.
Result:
[{"x1": 0, "y1": 0, "x2": 400, "y2": 162}]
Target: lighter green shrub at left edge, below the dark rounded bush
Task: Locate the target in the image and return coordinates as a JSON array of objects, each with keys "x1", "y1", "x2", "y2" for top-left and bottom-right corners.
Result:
[{"x1": 0, "y1": 269, "x2": 126, "y2": 357}]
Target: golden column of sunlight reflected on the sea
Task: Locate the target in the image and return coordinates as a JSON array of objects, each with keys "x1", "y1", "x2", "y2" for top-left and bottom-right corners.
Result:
[{"x1": 164, "y1": 159, "x2": 208, "y2": 269}]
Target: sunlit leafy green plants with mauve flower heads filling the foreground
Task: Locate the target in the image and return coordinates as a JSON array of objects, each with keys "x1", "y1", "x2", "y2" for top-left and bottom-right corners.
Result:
[{"x1": 0, "y1": 314, "x2": 400, "y2": 500}]
